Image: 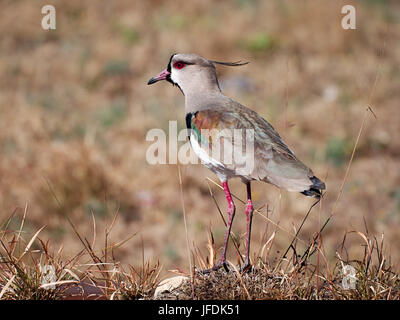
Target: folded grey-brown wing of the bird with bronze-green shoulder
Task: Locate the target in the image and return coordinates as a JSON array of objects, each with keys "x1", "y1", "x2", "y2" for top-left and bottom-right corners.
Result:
[{"x1": 188, "y1": 101, "x2": 313, "y2": 192}]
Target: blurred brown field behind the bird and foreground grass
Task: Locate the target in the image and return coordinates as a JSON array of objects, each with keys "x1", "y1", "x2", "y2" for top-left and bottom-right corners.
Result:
[{"x1": 0, "y1": 0, "x2": 400, "y2": 272}]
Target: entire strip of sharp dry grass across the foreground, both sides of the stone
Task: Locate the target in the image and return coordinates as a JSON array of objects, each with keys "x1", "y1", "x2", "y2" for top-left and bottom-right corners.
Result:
[{"x1": 0, "y1": 210, "x2": 400, "y2": 300}]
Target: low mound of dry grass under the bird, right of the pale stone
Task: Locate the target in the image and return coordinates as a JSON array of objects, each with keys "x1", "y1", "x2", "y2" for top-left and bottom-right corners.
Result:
[{"x1": 159, "y1": 250, "x2": 400, "y2": 300}]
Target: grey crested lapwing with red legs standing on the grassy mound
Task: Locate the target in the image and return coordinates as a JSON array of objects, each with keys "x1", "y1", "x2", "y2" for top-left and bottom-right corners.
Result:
[{"x1": 147, "y1": 53, "x2": 326, "y2": 272}]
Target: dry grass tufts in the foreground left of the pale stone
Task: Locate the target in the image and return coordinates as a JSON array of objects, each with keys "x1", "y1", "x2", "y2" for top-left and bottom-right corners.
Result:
[{"x1": 0, "y1": 210, "x2": 161, "y2": 300}]
